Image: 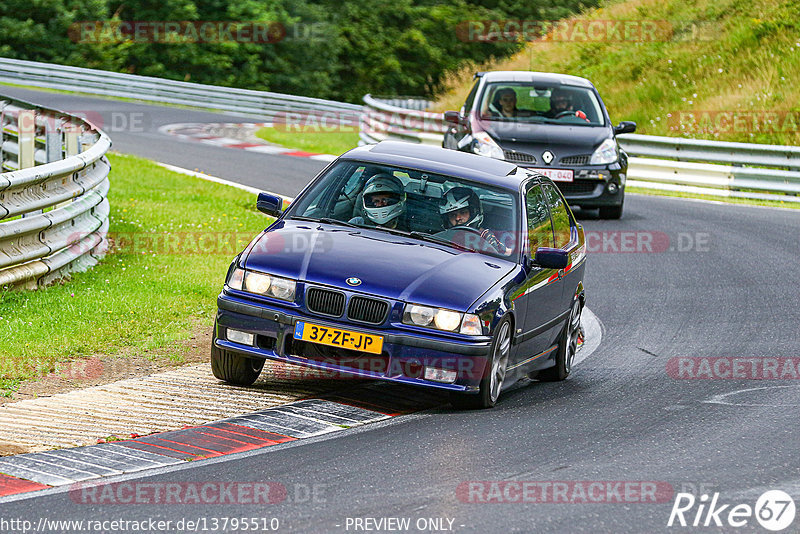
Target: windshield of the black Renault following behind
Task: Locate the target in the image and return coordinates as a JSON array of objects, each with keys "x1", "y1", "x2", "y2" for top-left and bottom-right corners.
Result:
[{"x1": 479, "y1": 82, "x2": 605, "y2": 126}]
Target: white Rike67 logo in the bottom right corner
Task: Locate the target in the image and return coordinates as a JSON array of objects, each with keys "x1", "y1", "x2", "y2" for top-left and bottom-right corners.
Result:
[{"x1": 667, "y1": 490, "x2": 796, "y2": 532}]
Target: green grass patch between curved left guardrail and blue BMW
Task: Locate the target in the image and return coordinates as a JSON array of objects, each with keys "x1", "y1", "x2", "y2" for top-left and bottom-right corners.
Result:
[{"x1": 0, "y1": 155, "x2": 270, "y2": 395}]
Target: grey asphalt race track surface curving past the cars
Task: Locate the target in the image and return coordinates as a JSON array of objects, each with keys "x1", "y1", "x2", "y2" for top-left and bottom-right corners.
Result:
[{"x1": 0, "y1": 88, "x2": 800, "y2": 532}]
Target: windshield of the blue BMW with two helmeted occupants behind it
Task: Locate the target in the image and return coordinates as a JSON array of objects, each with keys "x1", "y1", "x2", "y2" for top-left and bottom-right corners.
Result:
[{"x1": 286, "y1": 160, "x2": 519, "y2": 258}]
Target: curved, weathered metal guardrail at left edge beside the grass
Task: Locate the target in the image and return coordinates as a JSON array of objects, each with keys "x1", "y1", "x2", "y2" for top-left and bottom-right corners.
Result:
[{"x1": 0, "y1": 96, "x2": 111, "y2": 289}]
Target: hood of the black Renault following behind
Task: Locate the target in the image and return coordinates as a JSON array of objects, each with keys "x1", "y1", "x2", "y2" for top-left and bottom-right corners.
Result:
[{"x1": 481, "y1": 121, "x2": 612, "y2": 156}]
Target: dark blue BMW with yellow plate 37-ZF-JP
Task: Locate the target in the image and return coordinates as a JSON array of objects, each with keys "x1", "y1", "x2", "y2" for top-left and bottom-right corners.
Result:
[{"x1": 211, "y1": 142, "x2": 586, "y2": 407}]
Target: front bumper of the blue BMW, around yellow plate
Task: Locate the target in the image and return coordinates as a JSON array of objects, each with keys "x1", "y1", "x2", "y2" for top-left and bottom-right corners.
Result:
[{"x1": 213, "y1": 293, "x2": 491, "y2": 392}]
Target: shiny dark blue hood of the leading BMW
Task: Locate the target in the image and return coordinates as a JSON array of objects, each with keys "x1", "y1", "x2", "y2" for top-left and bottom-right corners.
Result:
[{"x1": 243, "y1": 221, "x2": 515, "y2": 311}]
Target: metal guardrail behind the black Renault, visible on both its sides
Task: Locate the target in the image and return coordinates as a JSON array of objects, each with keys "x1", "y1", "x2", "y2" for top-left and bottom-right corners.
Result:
[{"x1": 359, "y1": 95, "x2": 800, "y2": 202}]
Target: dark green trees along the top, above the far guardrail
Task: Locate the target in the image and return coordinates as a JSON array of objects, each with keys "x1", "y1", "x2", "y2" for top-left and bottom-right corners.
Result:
[{"x1": 0, "y1": 0, "x2": 596, "y2": 102}]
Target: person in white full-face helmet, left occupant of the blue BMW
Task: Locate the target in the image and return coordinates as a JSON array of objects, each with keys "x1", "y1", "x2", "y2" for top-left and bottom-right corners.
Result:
[{"x1": 350, "y1": 173, "x2": 406, "y2": 229}]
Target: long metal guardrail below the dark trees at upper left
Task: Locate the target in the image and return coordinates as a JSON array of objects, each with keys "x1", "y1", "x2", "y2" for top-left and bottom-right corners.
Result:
[{"x1": 0, "y1": 58, "x2": 361, "y2": 120}]
